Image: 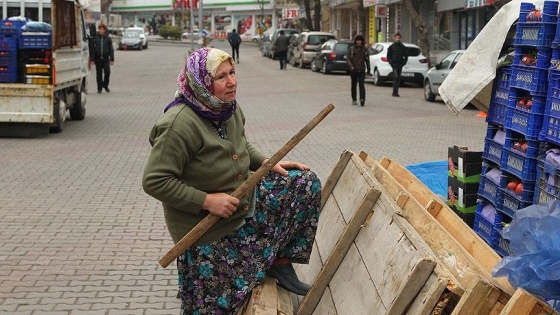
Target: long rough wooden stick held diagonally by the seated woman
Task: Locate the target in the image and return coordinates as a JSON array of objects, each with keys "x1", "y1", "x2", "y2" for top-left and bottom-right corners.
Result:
[{"x1": 159, "y1": 104, "x2": 334, "y2": 268}]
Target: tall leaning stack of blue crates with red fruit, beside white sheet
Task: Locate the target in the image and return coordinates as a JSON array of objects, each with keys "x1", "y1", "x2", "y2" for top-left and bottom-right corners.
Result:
[{"x1": 475, "y1": 1, "x2": 560, "y2": 256}]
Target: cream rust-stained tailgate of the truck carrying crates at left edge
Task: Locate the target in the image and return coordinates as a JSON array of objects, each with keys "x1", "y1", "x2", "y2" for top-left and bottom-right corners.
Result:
[{"x1": 0, "y1": 83, "x2": 54, "y2": 124}]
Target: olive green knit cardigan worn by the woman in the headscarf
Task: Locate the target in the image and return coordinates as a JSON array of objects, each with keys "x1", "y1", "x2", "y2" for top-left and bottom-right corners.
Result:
[{"x1": 142, "y1": 105, "x2": 265, "y2": 245}]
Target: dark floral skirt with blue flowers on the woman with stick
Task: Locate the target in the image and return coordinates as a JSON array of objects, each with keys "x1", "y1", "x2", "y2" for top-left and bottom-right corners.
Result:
[{"x1": 177, "y1": 170, "x2": 321, "y2": 315}]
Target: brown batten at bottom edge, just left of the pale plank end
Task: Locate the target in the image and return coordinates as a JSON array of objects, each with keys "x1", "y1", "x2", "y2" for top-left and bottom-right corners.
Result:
[{"x1": 387, "y1": 258, "x2": 436, "y2": 315}]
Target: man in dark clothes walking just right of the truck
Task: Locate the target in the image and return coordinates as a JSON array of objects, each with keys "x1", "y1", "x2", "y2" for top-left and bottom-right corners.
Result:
[{"x1": 90, "y1": 24, "x2": 115, "y2": 94}]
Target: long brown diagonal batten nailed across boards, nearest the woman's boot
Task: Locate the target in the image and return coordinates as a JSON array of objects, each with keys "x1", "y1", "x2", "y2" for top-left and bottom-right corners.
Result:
[{"x1": 297, "y1": 189, "x2": 380, "y2": 315}]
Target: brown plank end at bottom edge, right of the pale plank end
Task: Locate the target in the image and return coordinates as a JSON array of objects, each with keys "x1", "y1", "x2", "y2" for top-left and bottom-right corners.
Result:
[{"x1": 451, "y1": 279, "x2": 500, "y2": 315}]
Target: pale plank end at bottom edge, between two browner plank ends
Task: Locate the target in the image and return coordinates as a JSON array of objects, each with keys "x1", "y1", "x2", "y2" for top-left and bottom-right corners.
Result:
[{"x1": 406, "y1": 272, "x2": 449, "y2": 315}]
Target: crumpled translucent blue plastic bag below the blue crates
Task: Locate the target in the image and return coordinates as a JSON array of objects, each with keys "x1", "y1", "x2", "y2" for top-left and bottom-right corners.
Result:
[{"x1": 492, "y1": 200, "x2": 560, "y2": 300}]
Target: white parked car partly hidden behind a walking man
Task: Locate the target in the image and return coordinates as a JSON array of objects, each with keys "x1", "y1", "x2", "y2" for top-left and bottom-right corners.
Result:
[{"x1": 369, "y1": 43, "x2": 428, "y2": 86}]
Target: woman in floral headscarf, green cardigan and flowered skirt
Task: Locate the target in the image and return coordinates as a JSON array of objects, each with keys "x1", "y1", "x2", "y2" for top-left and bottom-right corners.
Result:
[{"x1": 142, "y1": 47, "x2": 321, "y2": 314}]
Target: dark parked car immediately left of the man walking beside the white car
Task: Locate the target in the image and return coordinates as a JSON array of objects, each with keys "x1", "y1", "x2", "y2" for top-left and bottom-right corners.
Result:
[{"x1": 311, "y1": 39, "x2": 352, "y2": 74}]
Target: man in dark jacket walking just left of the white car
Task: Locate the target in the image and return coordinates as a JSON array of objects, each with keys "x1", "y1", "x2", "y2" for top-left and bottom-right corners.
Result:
[{"x1": 346, "y1": 35, "x2": 371, "y2": 106}]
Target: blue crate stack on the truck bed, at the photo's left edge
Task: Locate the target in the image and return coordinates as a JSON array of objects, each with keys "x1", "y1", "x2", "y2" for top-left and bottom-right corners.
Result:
[{"x1": 0, "y1": 20, "x2": 24, "y2": 83}]
